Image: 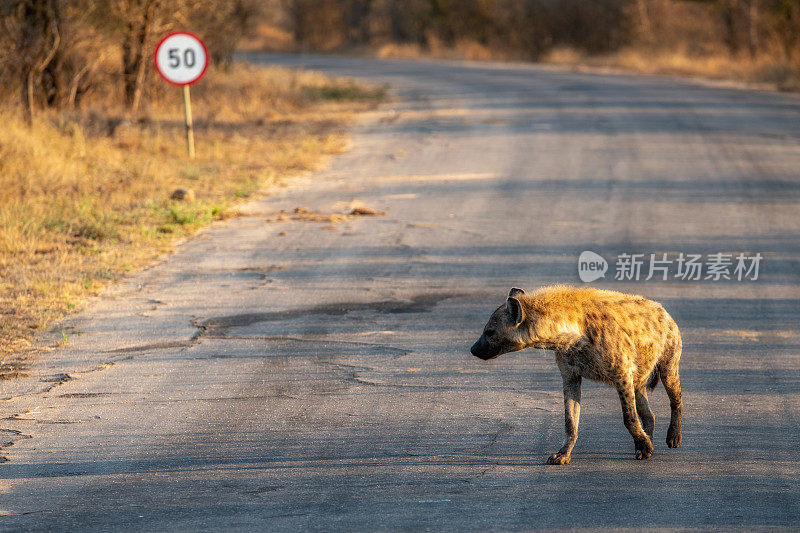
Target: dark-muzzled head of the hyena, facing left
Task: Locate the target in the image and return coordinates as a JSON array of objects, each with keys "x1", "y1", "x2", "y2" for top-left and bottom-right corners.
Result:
[{"x1": 470, "y1": 288, "x2": 528, "y2": 361}]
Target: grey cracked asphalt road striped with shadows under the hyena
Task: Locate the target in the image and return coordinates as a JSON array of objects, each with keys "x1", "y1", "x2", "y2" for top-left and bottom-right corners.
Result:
[{"x1": 0, "y1": 56, "x2": 800, "y2": 531}]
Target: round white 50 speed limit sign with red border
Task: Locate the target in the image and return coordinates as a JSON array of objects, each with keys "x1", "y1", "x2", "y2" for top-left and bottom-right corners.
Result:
[{"x1": 155, "y1": 31, "x2": 208, "y2": 85}]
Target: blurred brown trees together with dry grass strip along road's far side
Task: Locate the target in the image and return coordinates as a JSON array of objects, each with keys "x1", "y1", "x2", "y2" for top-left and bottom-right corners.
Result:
[{"x1": 276, "y1": 0, "x2": 800, "y2": 89}]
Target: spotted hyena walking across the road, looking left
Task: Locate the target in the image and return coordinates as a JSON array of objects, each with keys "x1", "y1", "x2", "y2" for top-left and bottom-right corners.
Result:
[{"x1": 471, "y1": 286, "x2": 683, "y2": 464}]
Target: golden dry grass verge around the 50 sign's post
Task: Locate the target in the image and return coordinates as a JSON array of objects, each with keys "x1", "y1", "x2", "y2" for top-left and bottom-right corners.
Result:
[{"x1": 0, "y1": 65, "x2": 384, "y2": 377}]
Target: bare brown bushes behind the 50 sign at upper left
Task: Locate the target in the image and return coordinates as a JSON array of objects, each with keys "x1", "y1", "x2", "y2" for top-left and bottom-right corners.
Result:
[{"x1": 0, "y1": 0, "x2": 265, "y2": 119}]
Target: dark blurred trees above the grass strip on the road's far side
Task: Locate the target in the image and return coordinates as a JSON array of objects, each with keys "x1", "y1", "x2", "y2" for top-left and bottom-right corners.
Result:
[{"x1": 284, "y1": 0, "x2": 800, "y2": 60}]
